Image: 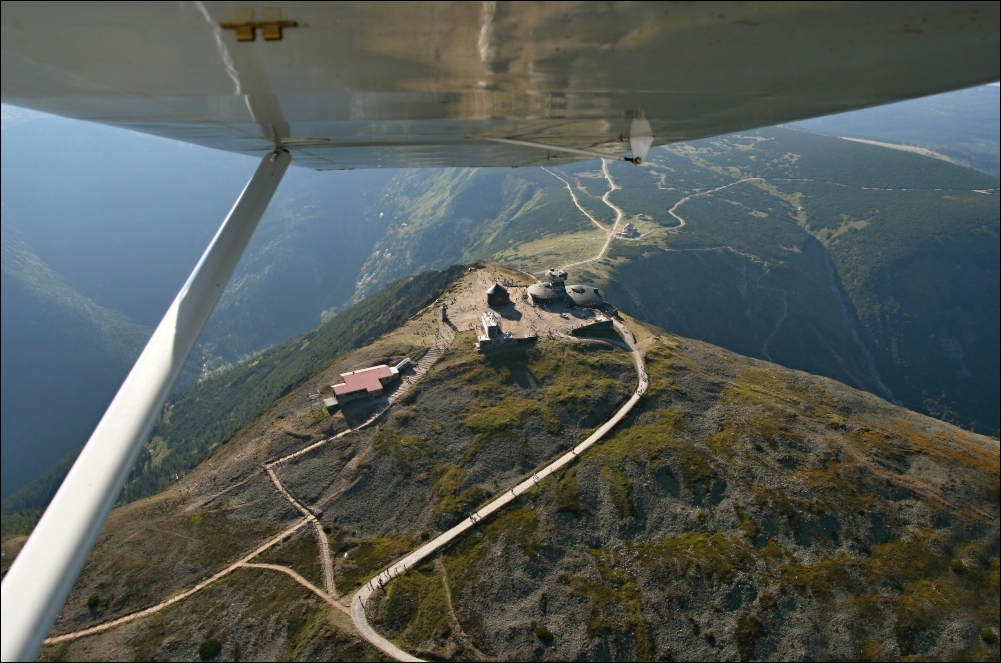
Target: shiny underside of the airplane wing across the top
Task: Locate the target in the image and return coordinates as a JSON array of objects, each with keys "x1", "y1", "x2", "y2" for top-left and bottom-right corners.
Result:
[{"x1": 0, "y1": 2, "x2": 1001, "y2": 170}]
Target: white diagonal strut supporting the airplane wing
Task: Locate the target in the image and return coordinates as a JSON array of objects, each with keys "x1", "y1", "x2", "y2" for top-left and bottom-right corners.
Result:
[{"x1": 0, "y1": 150, "x2": 291, "y2": 661}]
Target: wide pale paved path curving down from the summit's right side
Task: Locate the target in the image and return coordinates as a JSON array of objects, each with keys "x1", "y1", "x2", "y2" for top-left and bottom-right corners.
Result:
[{"x1": 351, "y1": 320, "x2": 650, "y2": 661}]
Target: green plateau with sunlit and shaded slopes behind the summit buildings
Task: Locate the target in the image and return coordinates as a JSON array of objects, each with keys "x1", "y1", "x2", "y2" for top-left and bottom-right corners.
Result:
[{"x1": 324, "y1": 128, "x2": 1001, "y2": 434}]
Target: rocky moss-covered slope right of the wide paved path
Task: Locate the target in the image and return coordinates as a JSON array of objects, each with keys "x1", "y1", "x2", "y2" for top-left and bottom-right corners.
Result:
[{"x1": 369, "y1": 320, "x2": 999, "y2": 660}]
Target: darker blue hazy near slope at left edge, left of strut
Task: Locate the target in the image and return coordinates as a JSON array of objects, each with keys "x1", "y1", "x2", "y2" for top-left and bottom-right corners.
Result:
[{"x1": 0, "y1": 220, "x2": 151, "y2": 498}]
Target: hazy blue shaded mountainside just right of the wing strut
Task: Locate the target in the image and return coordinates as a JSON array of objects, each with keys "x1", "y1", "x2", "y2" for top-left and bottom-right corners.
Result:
[{"x1": 191, "y1": 168, "x2": 398, "y2": 378}]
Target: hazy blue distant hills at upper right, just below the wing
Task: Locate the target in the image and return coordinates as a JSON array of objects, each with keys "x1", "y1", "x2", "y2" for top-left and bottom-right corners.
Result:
[{"x1": 791, "y1": 85, "x2": 1001, "y2": 175}]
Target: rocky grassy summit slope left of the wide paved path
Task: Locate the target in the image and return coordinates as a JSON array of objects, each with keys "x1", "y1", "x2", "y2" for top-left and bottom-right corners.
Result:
[{"x1": 21, "y1": 272, "x2": 636, "y2": 659}]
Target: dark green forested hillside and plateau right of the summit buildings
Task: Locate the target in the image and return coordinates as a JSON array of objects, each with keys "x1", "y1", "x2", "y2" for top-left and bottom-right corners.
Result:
[{"x1": 607, "y1": 129, "x2": 1001, "y2": 434}]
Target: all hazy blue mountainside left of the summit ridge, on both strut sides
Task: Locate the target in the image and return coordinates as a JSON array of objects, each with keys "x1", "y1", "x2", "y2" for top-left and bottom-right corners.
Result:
[{"x1": 0, "y1": 111, "x2": 392, "y2": 497}]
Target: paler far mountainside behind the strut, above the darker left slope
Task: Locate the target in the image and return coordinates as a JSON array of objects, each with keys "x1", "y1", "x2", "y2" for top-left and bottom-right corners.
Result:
[{"x1": 2, "y1": 107, "x2": 393, "y2": 384}]
